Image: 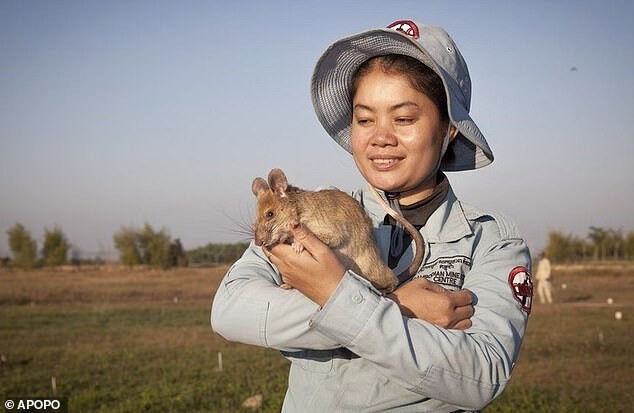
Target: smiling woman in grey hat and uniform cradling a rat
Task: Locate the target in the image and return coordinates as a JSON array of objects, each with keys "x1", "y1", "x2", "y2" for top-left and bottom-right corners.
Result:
[{"x1": 211, "y1": 21, "x2": 532, "y2": 412}]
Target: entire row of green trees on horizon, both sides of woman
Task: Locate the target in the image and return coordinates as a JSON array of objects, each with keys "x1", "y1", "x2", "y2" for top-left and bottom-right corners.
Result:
[{"x1": 0, "y1": 223, "x2": 634, "y2": 269}]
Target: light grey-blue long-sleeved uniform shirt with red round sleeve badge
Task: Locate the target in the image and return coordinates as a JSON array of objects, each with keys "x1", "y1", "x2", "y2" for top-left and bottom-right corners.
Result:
[{"x1": 211, "y1": 188, "x2": 532, "y2": 413}]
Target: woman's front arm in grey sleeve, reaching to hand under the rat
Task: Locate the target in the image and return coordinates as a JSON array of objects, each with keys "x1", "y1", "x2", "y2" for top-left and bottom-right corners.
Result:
[{"x1": 272, "y1": 222, "x2": 530, "y2": 409}]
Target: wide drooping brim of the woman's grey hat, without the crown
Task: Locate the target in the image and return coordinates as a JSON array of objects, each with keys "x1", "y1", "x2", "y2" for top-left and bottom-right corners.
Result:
[{"x1": 311, "y1": 29, "x2": 493, "y2": 171}]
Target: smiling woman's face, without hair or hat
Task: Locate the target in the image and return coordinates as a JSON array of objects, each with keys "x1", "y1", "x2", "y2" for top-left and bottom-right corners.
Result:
[{"x1": 351, "y1": 67, "x2": 455, "y2": 205}]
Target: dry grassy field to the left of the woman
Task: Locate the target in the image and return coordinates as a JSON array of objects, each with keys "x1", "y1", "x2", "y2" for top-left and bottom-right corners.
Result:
[{"x1": 0, "y1": 267, "x2": 288, "y2": 412}]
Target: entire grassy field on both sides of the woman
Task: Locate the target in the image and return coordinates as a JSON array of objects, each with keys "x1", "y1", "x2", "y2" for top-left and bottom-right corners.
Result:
[{"x1": 0, "y1": 265, "x2": 634, "y2": 412}]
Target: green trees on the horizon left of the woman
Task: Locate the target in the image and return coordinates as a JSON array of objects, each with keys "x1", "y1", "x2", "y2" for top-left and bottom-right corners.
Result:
[{"x1": 0, "y1": 223, "x2": 248, "y2": 269}]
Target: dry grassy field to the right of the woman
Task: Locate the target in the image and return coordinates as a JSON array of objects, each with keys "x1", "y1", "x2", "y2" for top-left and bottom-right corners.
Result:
[{"x1": 487, "y1": 264, "x2": 634, "y2": 413}]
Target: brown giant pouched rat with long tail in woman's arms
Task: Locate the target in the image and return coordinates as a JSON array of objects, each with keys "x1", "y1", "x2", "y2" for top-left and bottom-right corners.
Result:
[{"x1": 251, "y1": 169, "x2": 424, "y2": 291}]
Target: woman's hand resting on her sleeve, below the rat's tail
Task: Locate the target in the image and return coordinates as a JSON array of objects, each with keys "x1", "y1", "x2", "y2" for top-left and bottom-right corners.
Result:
[{"x1": 388, "y1": 277, "x2": 474, "y2": 330}]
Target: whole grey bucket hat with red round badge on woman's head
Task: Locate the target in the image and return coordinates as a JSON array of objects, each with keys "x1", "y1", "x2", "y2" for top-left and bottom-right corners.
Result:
[{"x1": 311, "y1": 20, "x2": 493, "y2": 171}]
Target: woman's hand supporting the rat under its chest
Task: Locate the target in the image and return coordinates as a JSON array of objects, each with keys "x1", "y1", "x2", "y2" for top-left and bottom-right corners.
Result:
[{"x1": 264, "y1": 225, "x2": 346, "y2": 307}]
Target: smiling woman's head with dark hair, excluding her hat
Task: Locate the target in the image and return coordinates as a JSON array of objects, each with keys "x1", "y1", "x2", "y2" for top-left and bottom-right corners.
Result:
[{"x1": 350, "y1": 55, "x2": 457, "y2": 205}]
